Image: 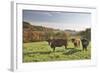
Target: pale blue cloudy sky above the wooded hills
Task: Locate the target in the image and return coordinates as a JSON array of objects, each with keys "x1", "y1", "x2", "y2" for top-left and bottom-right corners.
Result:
[{"x1": 23, "y1": 10, "x2": 91, "y2": 31}]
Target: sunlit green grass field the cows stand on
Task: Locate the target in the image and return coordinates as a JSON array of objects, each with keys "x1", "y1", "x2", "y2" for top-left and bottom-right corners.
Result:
[{"x1": 23, "y1": 41, "x2": 91, "y2": 62}]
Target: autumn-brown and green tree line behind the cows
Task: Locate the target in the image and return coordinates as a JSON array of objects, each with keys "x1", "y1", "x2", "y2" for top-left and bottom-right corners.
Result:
[{"x1": 23, "y1": 21, "x2": 91, "y2": 43}]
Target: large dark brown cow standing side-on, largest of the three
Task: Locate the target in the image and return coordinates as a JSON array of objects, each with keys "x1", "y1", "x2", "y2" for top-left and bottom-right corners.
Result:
[{"x1": 49, "y1": 39, "x2": 67, "y2": 51}]
